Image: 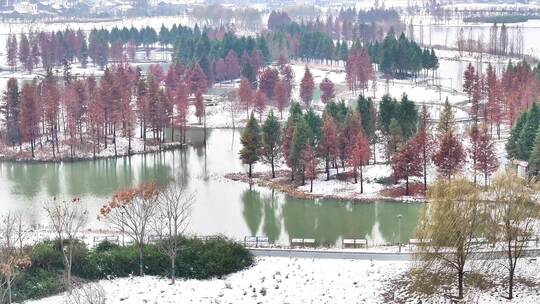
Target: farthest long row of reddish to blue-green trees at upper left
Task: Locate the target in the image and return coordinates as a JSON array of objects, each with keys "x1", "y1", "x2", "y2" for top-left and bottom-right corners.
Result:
[{"x1": 7, "y1": 24, "x2": 271, "y2": 76}]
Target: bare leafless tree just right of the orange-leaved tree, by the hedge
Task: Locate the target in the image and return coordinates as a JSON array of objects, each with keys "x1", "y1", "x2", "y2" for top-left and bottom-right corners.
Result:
[{"x1": 153, "y1": 181, "x2": 195, "y2": 284}]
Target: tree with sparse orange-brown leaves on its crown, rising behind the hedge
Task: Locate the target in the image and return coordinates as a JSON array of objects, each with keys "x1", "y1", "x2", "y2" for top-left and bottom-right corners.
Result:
[{"x1": 98, "y1": 183, "x2": 159, "y2": 276}]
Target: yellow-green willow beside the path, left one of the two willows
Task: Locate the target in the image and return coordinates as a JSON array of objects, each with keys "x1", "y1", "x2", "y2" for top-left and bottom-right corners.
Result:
[{"x1": 415, "y1": 179, "x2": 485, "y2": 299}]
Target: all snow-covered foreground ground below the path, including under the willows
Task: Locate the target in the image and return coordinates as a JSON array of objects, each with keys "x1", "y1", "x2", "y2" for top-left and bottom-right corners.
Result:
[{"x1": 27, "y1": 257, "x2": 540, "y2": 304}]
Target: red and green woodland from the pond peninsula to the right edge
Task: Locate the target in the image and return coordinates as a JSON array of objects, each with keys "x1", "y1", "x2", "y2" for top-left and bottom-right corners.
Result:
[{"x1": 240, "y1": 56, "x2": 540, "y2": 195}]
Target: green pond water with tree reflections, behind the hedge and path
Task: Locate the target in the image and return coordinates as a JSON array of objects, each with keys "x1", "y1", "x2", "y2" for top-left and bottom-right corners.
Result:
[{"x1": 0, "y1": 129, "x2": 421, "y2": 245}]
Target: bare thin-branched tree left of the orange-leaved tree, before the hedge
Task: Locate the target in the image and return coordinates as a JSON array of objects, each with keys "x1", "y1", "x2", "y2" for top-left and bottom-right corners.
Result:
[{"x1": 44, "y1": 198, "x2": 88, "y2": 293}]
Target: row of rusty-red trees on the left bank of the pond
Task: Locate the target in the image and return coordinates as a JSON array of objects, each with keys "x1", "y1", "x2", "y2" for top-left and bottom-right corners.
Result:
[{"x1": 0, "y1": 62, "x2": 208, "y2": 158}]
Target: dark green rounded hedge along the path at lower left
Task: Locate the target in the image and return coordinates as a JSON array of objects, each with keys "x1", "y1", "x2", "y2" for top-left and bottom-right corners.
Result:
[{"x1": 13, "y1": 237, "x2": 254, "y2": 301}]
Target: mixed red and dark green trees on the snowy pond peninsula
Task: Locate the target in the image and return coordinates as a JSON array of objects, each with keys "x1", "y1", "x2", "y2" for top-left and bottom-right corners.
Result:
[{"x1": 240, "y1": 95, "x2": 499, "y2": 195}]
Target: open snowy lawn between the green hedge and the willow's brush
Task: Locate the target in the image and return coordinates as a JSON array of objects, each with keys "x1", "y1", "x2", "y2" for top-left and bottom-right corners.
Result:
[{"x1": 28, "y1": 258, "x2": 408, "y2": 304}]
